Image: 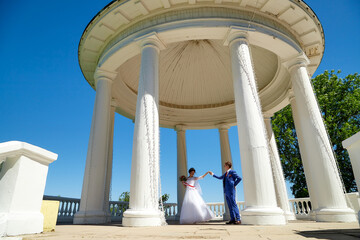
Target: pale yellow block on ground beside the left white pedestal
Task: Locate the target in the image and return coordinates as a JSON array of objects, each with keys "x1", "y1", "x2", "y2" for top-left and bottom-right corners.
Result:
[{"x1": 41, "y1": 200, "x2": 60, "y2": 232}]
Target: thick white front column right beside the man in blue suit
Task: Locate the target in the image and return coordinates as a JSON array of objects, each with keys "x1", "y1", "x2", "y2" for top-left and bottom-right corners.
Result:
[{"x1": 228, "y1": 30, "x2": 286, "y2": 225}]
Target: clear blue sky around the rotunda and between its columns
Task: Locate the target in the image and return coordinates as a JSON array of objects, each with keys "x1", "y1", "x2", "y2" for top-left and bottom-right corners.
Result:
[{"x1": 0, "y1": 0, "x2": 360, "y2": 202}]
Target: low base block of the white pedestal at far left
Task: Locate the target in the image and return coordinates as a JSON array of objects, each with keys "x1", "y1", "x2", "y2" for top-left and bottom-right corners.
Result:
[{"x1": 0, "y1": 212, "x2": 44, "y2": 236}]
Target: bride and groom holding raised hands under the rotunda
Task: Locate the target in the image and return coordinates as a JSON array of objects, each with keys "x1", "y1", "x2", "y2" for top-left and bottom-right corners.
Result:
[{"x1": 180, "y1": 162, "x2": 241, "y2": 224}]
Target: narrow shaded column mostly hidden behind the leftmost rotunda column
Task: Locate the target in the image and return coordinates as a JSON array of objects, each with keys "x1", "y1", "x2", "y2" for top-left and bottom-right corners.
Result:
[{"x1": 105, "y1": 106, "x2": 115, "y2": 222}]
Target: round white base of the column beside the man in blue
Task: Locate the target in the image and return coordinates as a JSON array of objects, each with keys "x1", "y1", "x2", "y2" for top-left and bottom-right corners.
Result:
[{"x1": 241, "y1": 207, "x2": 286, "y2": 225}]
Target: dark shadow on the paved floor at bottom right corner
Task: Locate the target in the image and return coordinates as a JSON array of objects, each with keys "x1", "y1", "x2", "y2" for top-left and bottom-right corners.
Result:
[{"x1": 297, "y1": 228, "x2": 360, "y2": 240}]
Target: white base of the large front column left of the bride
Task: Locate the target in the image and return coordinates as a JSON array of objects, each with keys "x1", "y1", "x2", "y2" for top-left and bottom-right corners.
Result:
[{"x1": 122, "y1": 209, "x2": 161, "y2": 227}]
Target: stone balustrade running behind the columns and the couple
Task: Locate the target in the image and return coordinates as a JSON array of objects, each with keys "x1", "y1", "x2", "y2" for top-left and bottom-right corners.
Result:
[{"x1": 43, "y1": 193, "x2": 360, "y2": 223}]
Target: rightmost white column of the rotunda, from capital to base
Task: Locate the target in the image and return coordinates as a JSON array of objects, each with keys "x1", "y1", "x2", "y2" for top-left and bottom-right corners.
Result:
[{"x1": 288, "y1": 56, "x2": 356, "y2": 222}]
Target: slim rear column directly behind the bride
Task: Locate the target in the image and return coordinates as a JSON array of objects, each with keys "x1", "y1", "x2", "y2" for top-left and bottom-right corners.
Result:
[{"x1": 175, "y1": 125, "x2": 188, "y2": 219}]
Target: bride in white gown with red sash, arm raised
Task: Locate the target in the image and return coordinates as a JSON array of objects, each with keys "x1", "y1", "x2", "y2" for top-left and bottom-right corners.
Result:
[{"x1": 180, "y1": 168, "x2": 214, "y2": 224}]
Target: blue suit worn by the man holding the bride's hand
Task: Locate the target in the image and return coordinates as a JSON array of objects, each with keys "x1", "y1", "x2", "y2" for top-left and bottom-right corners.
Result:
[{"x1": 213, "y1": 169, "x2": 241, "y2": 221}]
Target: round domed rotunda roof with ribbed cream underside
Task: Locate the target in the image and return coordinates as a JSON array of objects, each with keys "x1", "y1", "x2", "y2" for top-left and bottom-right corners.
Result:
[{"x1": 79, "y1": 0, "x2": 324, "y2": 129}]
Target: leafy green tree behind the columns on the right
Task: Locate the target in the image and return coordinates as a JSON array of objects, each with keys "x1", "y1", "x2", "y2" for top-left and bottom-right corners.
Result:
[{"x1": 272, "y1": 71, "x2": 360, "y2": 198}]
